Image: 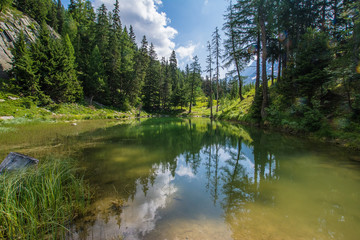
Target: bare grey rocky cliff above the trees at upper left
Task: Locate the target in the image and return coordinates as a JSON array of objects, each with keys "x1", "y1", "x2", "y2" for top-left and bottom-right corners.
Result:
[{"x1": 0, "y1": 10, "x2": 59, "y2": 78}]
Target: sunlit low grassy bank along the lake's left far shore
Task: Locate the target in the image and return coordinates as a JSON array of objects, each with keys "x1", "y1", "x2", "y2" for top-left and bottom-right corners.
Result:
[{"x1": 0, "y1": 92, "x2": 216, "y2": 123}]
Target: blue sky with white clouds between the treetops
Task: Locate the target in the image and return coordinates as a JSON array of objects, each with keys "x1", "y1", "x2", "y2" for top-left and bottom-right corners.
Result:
[{"x1": 63, "y1": 0, "x2": 229, "y2": 78}]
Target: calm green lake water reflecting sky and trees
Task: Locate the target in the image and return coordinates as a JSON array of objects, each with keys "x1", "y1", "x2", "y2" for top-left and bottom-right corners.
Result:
[{"x1": 0, "y1": 119, "x2": 360, "y2": 240}]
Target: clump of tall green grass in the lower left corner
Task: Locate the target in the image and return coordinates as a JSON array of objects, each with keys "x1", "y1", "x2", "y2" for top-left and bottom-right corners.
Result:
[{"x1": 0, "y1": 159, "x2": 90, "y2": 239}]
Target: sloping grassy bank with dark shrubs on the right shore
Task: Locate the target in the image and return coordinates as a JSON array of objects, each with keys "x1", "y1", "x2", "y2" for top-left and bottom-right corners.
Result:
[{"x1": 215, "y1": 86, "x2": 360, "y2": 149}]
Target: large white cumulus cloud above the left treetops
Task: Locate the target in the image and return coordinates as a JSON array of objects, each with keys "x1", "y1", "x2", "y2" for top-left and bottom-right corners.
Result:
[{"x1": 94, "y1": 0, "x2": 178, "y2": 57}]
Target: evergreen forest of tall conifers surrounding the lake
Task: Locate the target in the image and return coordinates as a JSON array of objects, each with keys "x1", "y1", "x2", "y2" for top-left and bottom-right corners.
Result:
[{"x1": 0, "y1": 0, "x2": 360, "y2": 142}]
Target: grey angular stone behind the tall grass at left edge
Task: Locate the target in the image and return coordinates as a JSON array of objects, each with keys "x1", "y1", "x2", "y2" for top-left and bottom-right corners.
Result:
[{"x1": 0, "y1": 152, "x2": 39, "y2": 174}]
